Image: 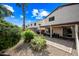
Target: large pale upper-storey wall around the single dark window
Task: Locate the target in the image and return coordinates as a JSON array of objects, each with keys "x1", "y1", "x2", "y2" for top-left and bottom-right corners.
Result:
[{"x1": 42, "y1": 4, "x2": 79, "y2": 25}]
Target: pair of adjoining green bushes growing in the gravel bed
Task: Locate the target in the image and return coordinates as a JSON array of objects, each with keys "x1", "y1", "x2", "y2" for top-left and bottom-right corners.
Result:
[{"x1": 23, "y1": 29, "x2": 46, "y2": 51}]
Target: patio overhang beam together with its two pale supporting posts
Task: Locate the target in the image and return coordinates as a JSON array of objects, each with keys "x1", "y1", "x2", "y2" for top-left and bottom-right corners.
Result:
[{"x1": 40, "y1": 21, "x2": 79, "y2": 56}]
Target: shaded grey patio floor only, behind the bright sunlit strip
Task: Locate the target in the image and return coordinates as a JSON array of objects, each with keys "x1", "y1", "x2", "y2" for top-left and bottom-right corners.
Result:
[{"x1": 45, "y1": 36, "x2": 76, "y2": 49}]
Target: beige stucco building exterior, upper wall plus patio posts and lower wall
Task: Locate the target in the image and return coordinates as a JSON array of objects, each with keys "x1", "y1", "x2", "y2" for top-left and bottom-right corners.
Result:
[{"x1": 26, "y1": 4, "x2": 79, "y2": 55}]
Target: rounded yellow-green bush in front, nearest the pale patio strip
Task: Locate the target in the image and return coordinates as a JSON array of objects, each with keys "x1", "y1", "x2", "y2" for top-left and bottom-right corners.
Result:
[{"x1": 31, "y1": 36, "x2": 46, "y2": 51}]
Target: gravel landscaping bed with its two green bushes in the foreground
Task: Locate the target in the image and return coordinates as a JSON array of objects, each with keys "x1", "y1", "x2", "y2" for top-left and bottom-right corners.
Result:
[{"x1": 0, "y1": 26, "x2": 74, "y2": 56}]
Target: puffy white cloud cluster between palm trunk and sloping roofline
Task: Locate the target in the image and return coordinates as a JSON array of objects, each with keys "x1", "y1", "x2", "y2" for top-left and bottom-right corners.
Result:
[{"x1": 32, "y1": 9, "x2": 49, "y2": 19}]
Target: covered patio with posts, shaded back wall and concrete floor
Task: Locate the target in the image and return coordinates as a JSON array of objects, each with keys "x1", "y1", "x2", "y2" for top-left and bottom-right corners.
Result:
[{"x1": 40, "y1": 23, "x2": 79, "y2": 55}]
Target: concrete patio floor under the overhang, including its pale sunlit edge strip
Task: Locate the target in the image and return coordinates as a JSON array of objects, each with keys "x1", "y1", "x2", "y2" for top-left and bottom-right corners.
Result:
[{"x1": 45, "y1": 36, "x2": 77, "y2": 55}]
